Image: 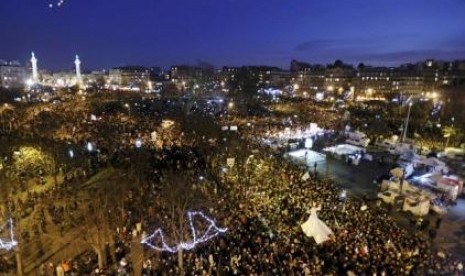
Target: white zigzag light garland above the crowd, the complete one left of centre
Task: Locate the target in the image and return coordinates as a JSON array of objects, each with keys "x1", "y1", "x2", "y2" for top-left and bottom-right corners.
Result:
[{"x1": 141, "y1": 211, "x2": 228, "y2": 253}]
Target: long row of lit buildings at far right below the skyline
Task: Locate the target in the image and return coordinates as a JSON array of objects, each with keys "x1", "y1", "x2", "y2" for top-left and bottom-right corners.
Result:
[{"x1": 291, "y1": 60, "x2": 465, "y2": 99}]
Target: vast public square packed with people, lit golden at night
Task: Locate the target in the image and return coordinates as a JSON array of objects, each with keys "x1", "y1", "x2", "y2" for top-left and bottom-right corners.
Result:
[{"x1": 2, "y1": 90, "x2": 464, "y2": 275}]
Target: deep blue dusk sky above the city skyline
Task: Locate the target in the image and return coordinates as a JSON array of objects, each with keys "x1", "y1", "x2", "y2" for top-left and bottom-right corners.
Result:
[{"x1": 0, "y1": 0, "x2": 465, "y2": 70}]
